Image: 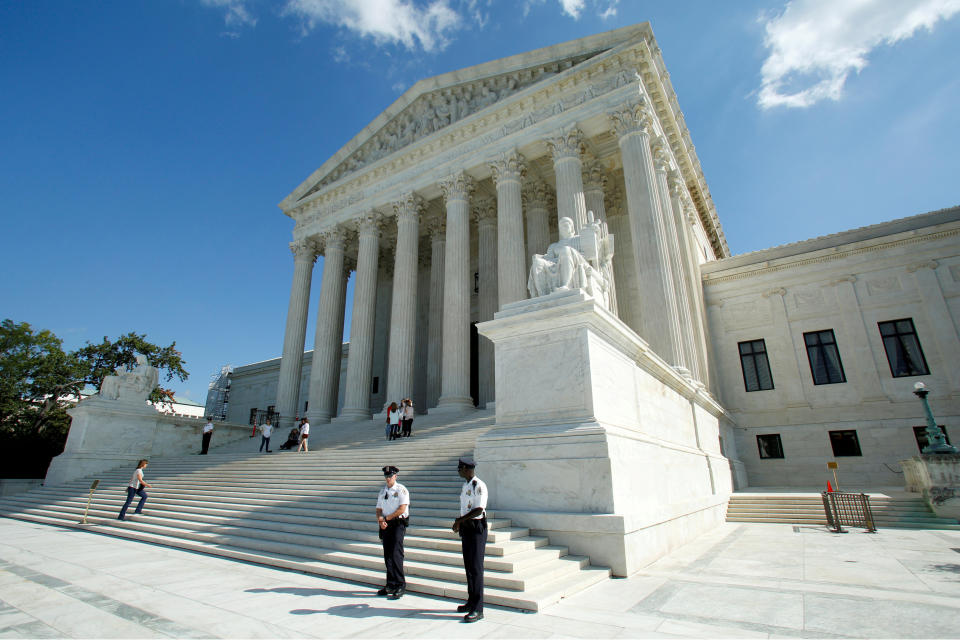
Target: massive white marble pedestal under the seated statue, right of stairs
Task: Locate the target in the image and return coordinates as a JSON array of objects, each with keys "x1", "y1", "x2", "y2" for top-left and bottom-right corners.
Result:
[{"x1": 475, "y1": 290, "x2": 732, "y2": 576}]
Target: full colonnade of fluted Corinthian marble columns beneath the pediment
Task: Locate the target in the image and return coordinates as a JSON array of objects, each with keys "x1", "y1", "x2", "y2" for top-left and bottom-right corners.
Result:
[{"x1": 277, "y1": 101, "x2": 708, "y2": 424}]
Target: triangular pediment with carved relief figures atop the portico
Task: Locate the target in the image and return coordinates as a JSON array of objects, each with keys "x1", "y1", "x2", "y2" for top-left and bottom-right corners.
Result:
[{"x1": 281, "y1": 23, "x2": 650, "y2": 208}]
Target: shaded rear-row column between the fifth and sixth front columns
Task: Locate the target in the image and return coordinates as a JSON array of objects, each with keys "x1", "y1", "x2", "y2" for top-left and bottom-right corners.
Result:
[{"x1": 474, "y1": 200, "x2": 502, "y2": 407}]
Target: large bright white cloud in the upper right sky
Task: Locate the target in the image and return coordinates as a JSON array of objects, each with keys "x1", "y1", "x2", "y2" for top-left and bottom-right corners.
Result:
[{"x1": 757, "y1": 0, "x2": 960, "y2": 109}]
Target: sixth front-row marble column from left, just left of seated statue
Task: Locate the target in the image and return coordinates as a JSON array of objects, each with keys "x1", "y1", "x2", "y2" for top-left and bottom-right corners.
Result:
[{"x1": 492, "y1": 151, "x2": 527, "y2": 308}]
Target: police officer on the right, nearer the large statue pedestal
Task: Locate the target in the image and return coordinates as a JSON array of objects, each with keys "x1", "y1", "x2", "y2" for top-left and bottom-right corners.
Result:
[{"x1": 452, "y1": 458, "x2": 487, "y2": 622}]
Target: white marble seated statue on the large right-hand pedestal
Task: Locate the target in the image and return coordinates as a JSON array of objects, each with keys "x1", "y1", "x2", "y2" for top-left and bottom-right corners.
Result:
[{"x1": 527, "y1": 211, "x2": 613, "y2": 310}]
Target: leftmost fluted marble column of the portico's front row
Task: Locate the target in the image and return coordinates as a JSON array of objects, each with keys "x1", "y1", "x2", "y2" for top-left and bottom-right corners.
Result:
[{"x1": 277, "y1": 240, "x2": 317, "y2": 427}]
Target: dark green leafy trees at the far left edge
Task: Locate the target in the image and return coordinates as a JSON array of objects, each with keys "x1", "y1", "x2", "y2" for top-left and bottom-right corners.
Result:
[{"x1": 0, "y1": 319, "x2": 189, "y2": 478}]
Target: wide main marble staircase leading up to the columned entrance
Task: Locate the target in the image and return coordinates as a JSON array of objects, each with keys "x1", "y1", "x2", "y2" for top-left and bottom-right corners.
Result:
[{"x1": 0, "y1": 411, "x2": 610, "y2": 611}]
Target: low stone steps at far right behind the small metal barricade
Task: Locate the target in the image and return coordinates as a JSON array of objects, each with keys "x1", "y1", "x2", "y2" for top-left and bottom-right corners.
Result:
[{"x1": 727, "y1": 490, "x2": 960, "y2": 530}]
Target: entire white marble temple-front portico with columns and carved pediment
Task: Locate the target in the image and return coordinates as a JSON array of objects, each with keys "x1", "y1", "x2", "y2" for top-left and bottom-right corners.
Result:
[{"x1": 276, "y1": 24, "x2": 729, "y2": 423}]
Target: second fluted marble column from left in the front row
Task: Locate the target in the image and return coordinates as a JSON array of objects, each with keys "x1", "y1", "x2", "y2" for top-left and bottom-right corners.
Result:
[{"x1": 307, "y1": 228, "x2": 346, "y2": 422}]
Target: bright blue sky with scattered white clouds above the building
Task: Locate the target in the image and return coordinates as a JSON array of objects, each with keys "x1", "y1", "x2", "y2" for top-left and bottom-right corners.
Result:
[{"x1": 0, "y1": 0, "x2": 960, "y2": 402}]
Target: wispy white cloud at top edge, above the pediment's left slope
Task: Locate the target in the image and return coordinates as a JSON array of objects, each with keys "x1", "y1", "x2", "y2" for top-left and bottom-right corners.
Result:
[{"x1": 283, "y1": 0, "x2": 461, "y2": 51}]
